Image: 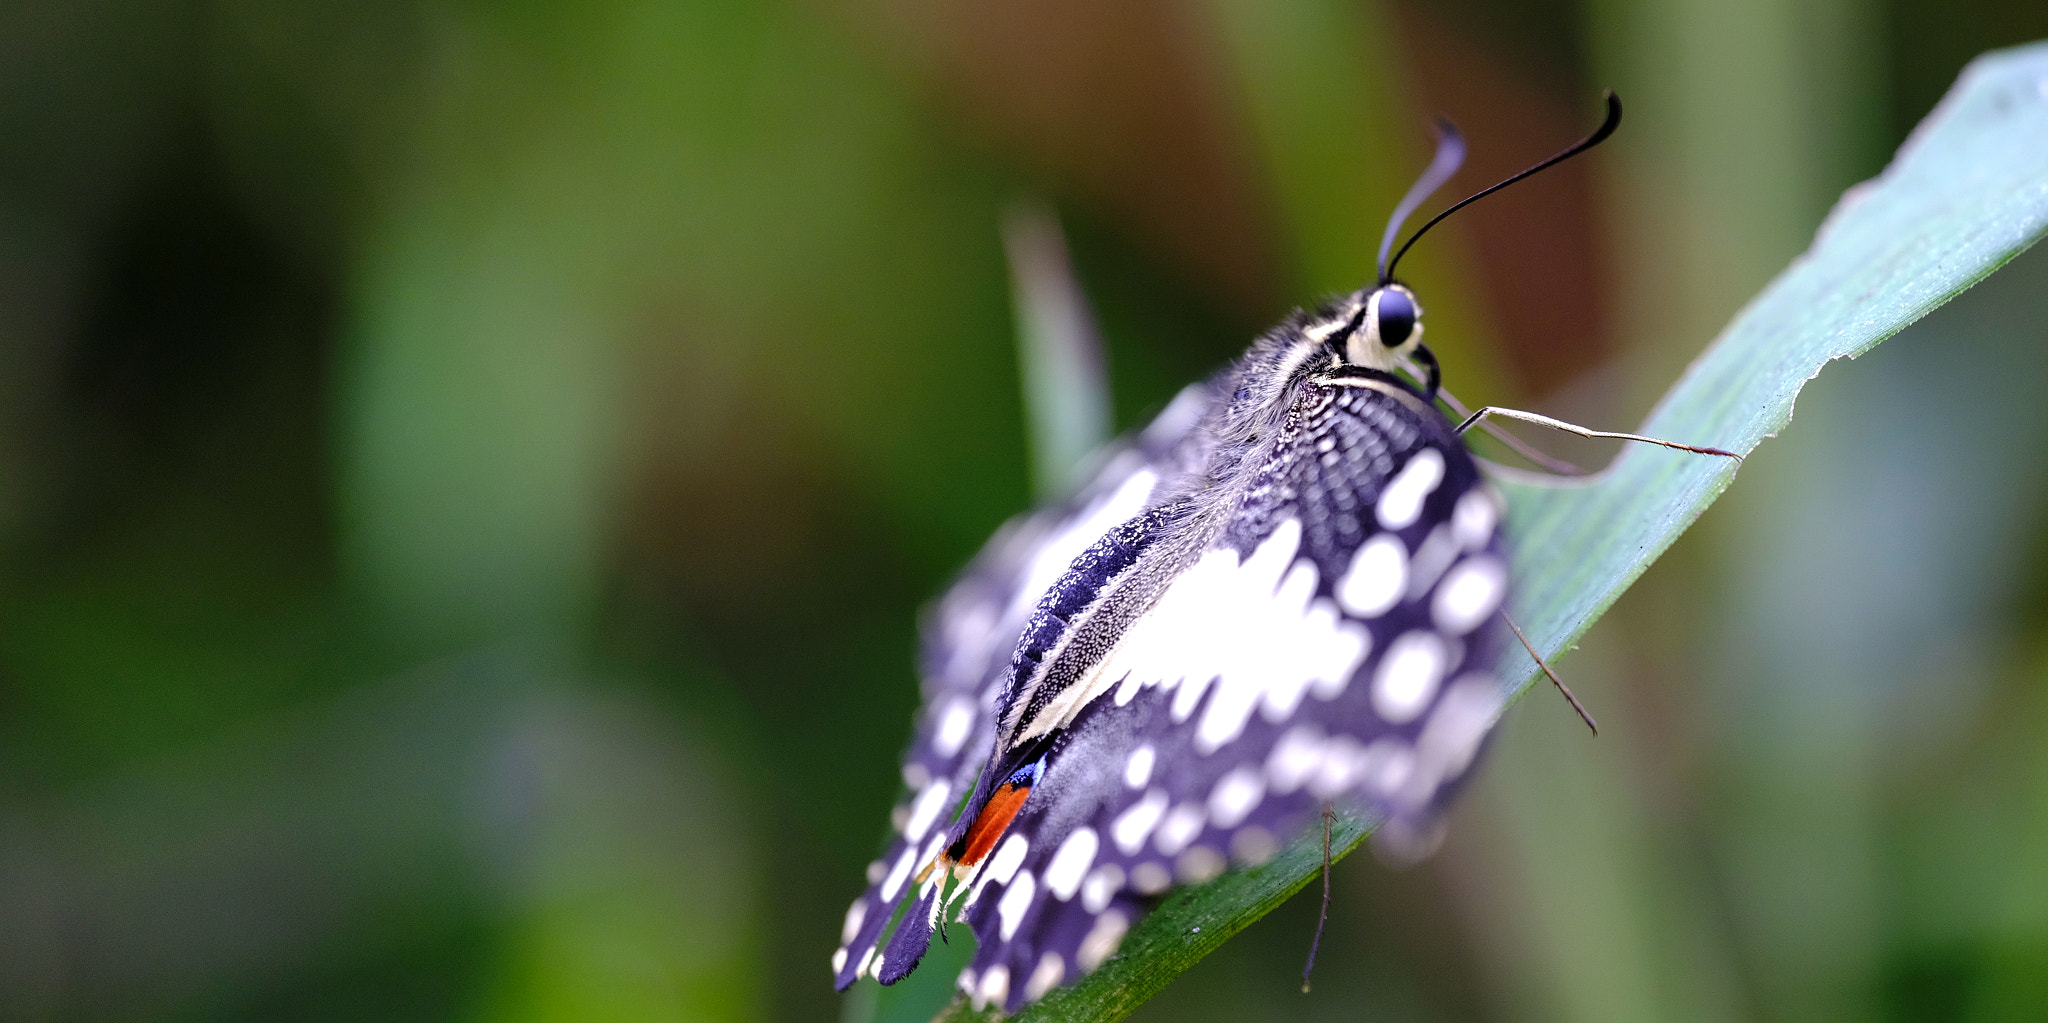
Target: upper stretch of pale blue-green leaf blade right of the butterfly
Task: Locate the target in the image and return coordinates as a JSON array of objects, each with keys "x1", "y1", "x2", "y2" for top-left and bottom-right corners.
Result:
[{"x1": 1501, "y1": 45, "x2": 2048, "y2": 671}]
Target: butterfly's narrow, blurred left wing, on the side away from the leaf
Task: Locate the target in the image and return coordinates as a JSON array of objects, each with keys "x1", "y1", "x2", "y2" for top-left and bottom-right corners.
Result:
[{"x1": 831, "y1": 383, "x2": 1221, "y2": 990}]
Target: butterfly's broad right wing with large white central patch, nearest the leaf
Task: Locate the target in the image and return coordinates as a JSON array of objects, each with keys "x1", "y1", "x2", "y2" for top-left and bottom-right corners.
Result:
[{"x1": 950, "y1": 372, "x2": 1507, "y2": 1011}]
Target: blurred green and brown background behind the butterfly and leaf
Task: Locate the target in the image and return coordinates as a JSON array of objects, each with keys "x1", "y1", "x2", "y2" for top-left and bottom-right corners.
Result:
[{"x1": 0, "y1": 0, "x2": 2048, "y2": 1023}]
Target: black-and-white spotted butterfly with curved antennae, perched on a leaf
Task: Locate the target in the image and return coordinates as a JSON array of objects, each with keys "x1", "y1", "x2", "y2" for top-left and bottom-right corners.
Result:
[{"x1": 831, "y1": 94, "x2": 1724, "y2": 1011}]
